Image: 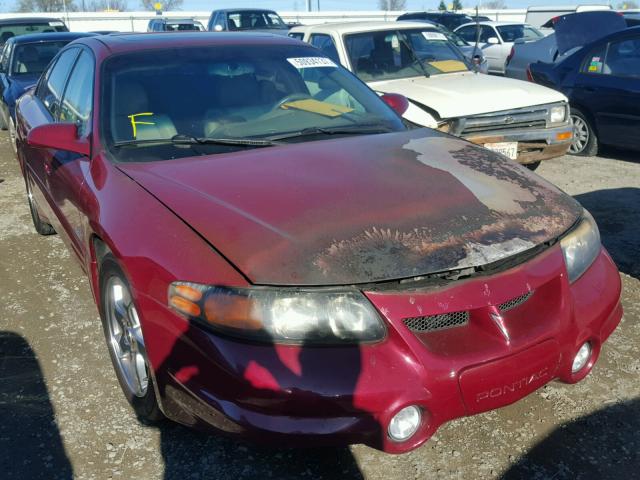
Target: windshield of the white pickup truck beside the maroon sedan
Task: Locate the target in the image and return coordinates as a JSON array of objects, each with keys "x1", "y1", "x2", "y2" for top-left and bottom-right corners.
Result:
[{"x1": 345, "y1": 29, "x2": 469, "y2": 82}]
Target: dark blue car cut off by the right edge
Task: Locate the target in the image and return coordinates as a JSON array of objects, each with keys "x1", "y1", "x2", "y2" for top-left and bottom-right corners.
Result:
[{"x1": 530, "y1": 27, "x2": 640, "y2": 156}]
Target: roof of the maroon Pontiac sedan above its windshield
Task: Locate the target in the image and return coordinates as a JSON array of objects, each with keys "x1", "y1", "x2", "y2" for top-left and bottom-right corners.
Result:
[{"x1": 79, "y1": 31, "x2": 301, "y2": 55}]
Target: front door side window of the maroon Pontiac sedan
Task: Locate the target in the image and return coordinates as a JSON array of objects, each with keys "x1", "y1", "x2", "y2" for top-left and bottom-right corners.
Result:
[{"x1": 60, "y1": 51, "x2": 94, "y2": 136}]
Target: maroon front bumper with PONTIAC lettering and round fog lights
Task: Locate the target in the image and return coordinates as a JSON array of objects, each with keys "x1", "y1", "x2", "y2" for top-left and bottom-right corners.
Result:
[{"x1": 137, "y1": 245, "x2": 622, "y2": 453}]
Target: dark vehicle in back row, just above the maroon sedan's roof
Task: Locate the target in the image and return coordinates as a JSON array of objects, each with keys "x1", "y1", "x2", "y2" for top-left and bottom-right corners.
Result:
[{"x1": 207, "y1": 8, "x2": 291, "y2": 35}]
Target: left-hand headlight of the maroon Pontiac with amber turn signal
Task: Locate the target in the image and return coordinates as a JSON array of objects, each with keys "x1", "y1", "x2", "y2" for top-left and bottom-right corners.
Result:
[{"x1": 169, "y1": 282, "x2": 385, "y2": 344}]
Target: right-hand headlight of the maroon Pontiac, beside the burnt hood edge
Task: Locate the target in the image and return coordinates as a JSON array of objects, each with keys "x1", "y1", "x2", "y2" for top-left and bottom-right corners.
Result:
[{"x1": 560, "y1": 210, "x2": 600, "y2": 283}]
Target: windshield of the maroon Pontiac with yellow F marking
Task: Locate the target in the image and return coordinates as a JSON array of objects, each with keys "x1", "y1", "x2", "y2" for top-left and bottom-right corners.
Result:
[{"x1": 102, "y1": 45, "x2": 404, "y2": 161}]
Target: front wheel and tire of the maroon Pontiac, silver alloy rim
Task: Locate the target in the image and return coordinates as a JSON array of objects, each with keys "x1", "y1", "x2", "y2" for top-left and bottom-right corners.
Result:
[{"x1": 100, "y1": 254, "x2": 164, "y2": 423}]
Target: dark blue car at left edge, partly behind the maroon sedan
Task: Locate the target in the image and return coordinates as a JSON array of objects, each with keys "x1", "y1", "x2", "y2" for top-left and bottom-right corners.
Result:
[{"x1": 0, "y1": 32, "x2": 95, "y2": 144}]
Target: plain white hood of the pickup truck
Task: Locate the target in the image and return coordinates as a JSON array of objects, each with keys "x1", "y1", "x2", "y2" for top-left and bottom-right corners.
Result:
[{"x1": 368, "y1": 72, "x2": 567, "y2": 119}]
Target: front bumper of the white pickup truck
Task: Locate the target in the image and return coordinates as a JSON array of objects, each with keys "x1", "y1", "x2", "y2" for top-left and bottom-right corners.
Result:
[{"x1": 463, "y1": 123, "x2": 573, "y2": 165}]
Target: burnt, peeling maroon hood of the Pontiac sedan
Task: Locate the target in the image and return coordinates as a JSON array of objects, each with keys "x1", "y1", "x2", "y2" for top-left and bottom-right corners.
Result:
[{"x1": 118, "y1": 129, "x2": 582, "y2": 285}]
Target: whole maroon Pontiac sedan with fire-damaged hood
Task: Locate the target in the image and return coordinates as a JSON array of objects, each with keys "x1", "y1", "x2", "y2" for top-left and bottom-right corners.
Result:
[{"x1": 17, "y1": 34, "x2": 622, "y2": 453}]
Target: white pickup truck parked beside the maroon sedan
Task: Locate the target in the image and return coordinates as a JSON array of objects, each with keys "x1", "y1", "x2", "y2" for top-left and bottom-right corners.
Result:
[{"x1": 291, "y1": 22, "x2": 573, "y2": 169}]
